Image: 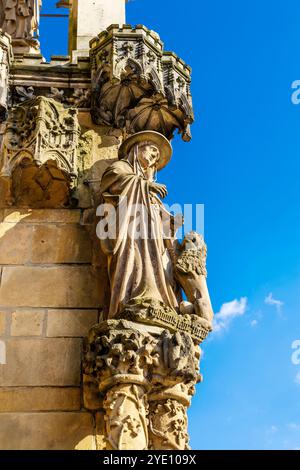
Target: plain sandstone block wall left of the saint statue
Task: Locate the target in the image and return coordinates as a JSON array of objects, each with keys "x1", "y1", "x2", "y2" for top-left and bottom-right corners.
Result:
[{"x1": 0, "y1": 208, "x2": 103, "y2": 450}]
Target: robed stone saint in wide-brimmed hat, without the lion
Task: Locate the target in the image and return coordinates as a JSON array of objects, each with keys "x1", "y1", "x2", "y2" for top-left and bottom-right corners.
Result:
[{"x1": 98, "y1": 131, "x2": 179, "y2": 318}]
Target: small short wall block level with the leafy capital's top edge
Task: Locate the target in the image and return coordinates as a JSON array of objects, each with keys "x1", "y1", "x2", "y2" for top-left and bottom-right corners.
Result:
[{"x1": 47, "y1": 310, "x2": 98, "y2": 337}]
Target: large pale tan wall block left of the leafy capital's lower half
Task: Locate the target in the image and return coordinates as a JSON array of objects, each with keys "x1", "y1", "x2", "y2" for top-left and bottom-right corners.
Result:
[{"x1": 0, "y1": 338, "x2": 81, "y2": 387}]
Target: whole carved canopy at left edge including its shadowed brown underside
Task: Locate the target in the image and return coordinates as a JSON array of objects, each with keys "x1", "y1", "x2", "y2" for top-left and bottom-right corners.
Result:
[{"x1": 0, "y1": 97, "x2": 80, "y2": 207}]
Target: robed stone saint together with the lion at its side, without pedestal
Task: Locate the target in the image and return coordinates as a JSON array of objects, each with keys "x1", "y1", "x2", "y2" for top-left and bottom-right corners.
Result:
[{"x1": 98, "y1": 131, "x2": 213, "y2": 329}]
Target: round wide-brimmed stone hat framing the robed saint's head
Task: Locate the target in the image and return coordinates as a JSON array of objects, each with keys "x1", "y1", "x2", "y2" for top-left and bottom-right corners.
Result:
[{"x1": 119, "y1": 131, "x2": 173, "y2": 170}]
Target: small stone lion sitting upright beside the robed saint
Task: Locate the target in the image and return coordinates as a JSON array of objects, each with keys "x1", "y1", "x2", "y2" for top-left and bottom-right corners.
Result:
[{"x1": 175, "y1": 232, "x2": 214, "y2": 329}]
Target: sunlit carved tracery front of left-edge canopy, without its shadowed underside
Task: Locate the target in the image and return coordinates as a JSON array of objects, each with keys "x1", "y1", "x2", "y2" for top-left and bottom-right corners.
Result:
[{"x1": 1, "y1": 96, "x2": 80, "y2": 176}]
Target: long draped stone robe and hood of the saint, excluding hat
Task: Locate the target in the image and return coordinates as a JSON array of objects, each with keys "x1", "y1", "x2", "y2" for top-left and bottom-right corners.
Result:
[{"x1": 101, "y1": 150, "x2": 178, "y2": 318}]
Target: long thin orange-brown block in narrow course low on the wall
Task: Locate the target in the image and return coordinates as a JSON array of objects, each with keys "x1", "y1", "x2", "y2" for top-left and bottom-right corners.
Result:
[{"x1": 0, "y1": 387, "x2": 80, "y2": 414}]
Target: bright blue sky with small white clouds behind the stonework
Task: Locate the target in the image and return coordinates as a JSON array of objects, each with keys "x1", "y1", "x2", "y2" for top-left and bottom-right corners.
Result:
[{"x1": 41, "y1": 0, "x2": 300, "y2": 449}]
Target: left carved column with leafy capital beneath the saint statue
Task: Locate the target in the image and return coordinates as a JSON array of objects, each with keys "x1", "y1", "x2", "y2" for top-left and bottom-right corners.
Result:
[{"x1": 83, "y1": 320, "x2": 155, "y2": 450}]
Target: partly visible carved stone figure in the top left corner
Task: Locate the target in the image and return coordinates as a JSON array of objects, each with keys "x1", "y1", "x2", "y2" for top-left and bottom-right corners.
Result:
[{"x1": 0, "y1": 0, "x2": 41, "y2": 39}]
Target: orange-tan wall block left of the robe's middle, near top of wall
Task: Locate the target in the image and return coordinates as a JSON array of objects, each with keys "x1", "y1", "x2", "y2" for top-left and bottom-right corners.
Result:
[{"x1": 31, "y1": 225, "x2": 92, "y2": 264}]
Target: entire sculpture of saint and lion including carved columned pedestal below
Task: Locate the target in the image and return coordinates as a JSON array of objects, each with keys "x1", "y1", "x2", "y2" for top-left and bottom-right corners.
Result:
[{"x1": 83, "y1": 131, "x2": 213, "y2": 450}]
